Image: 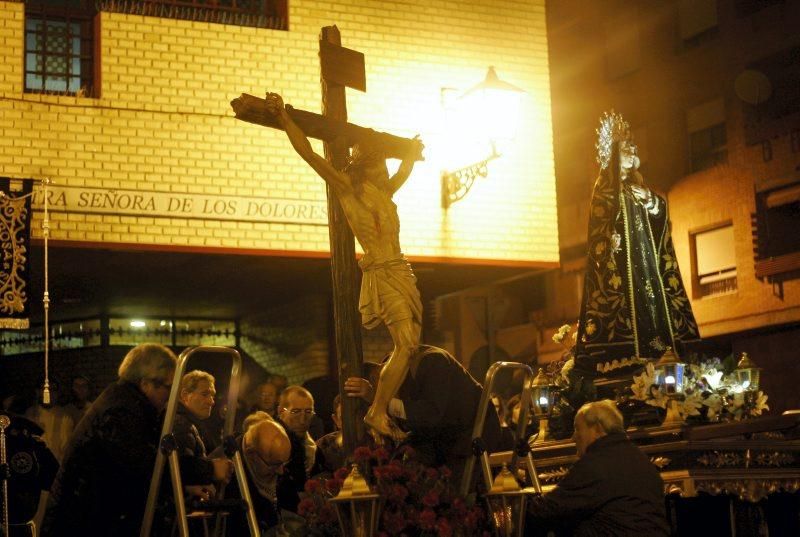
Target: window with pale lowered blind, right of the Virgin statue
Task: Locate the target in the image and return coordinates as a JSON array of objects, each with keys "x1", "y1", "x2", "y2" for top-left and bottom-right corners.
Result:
[{"x1": 692, "y1": 224, "x2": 738, "y2": 298}]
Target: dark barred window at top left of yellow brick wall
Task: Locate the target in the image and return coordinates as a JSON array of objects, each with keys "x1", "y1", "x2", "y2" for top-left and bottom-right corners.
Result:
[{"x1": 25, "y1": 0, "x2": 96, "y2": 97}]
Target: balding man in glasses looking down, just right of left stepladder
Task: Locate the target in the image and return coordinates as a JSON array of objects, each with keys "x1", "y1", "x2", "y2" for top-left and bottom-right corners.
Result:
[{"x1": 216, "y1": 412, "x2": 292, "y2": 535}]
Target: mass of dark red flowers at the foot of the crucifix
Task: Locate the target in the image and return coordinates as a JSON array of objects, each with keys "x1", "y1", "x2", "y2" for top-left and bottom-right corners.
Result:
[{"x1": 298, "y1": 446, "x2": 490, "y2": 537}]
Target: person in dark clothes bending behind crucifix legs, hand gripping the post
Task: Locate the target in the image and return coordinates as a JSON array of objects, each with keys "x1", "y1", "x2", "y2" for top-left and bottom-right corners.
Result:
[{"x1": 344, "y1": 345, "x2": 509, "y2": 476}]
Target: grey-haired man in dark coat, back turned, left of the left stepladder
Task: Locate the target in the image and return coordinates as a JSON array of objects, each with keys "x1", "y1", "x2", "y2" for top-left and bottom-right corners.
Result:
[{"x1": 42, "y1": 343, "x2": 176, "y2": 537}]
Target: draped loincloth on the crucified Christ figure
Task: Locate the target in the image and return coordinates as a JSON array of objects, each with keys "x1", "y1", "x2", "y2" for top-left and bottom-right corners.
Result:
[{"x1": 358, "y1": 254, "x2": 422, "y2": 328}]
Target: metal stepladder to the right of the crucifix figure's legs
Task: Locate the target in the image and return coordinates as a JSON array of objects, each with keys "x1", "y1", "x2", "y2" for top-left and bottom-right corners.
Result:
[{"x1": 460, "y1": 362, "x2": 542, "y2": 496}]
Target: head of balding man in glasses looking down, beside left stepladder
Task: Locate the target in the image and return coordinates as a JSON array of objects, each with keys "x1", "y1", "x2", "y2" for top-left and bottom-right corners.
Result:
[{"x1": 242, "y1": 412, "x2": 292, "y2": 480}]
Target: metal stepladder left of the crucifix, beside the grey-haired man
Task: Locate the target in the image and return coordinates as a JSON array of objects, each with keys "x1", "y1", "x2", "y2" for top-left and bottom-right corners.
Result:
[{"x1": 139, "y1": 346, "x2": 260, "y2": 537}]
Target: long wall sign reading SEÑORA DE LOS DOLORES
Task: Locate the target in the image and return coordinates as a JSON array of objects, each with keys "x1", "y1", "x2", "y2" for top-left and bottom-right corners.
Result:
[{"x1": 33, "y1": 185, "x2": 328, "y2": 226}]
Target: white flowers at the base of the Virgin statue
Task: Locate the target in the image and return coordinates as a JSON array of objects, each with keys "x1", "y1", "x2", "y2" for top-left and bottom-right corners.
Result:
[{"x1": 631, "y1": 358, "x2": 769, "y2": 421}]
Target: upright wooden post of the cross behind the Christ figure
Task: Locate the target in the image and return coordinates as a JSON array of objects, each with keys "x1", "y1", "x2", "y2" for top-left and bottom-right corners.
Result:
[{"x1": 320, "y1": 26, "x2": 364, "y2": 453}]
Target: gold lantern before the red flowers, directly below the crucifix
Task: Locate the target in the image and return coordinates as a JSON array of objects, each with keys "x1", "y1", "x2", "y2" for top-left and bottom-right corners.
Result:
[{"x1": 328, "y1": 464, "x2": 382, "y2": 537}]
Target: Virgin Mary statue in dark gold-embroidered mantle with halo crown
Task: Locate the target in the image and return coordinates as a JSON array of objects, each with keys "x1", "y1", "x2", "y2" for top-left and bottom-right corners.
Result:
[{"x1": 575, "y1": 111, "x2": 700, "y2": 376}]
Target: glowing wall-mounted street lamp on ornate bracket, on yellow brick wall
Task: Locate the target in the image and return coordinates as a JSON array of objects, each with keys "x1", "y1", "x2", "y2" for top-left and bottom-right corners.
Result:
[{"x1": 441, "y1": 67, "x2": 525, "y2": 209}]
